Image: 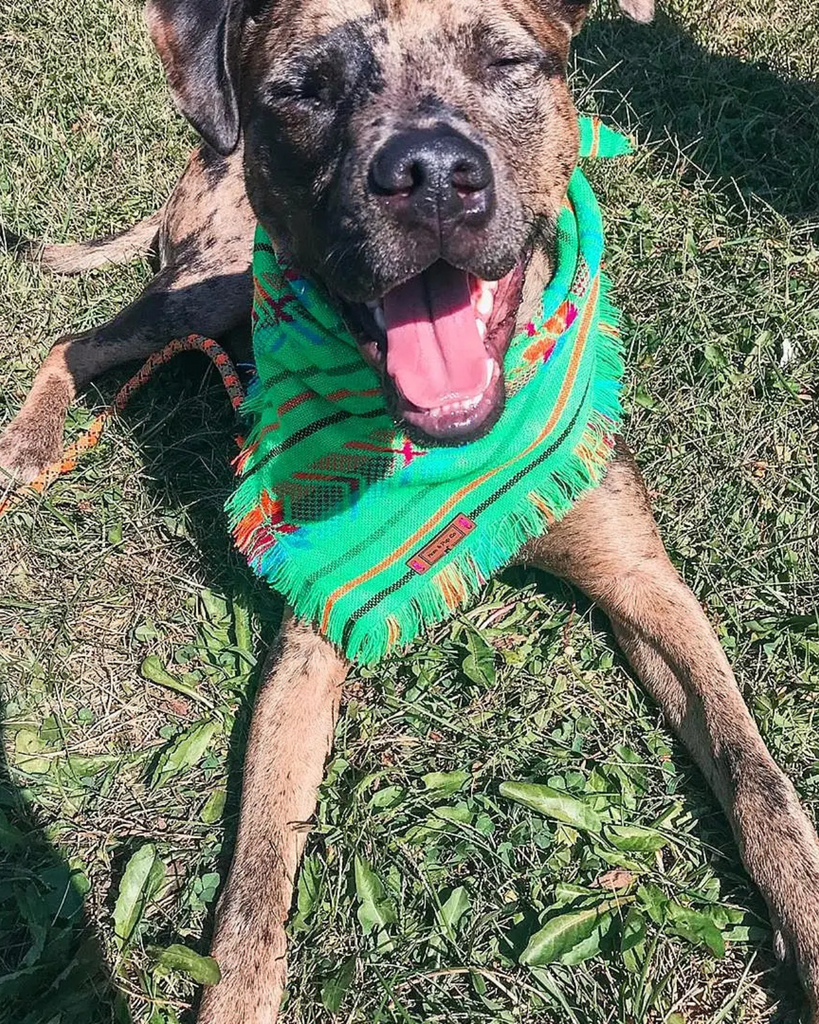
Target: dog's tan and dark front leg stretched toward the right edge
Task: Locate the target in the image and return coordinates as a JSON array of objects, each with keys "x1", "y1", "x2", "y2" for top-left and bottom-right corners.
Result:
[{"x1": 526, "y1": 450, "x2": 819, "y2": 1024}]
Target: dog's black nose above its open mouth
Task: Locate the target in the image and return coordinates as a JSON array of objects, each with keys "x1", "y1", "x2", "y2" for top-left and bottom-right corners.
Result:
[{"x1": 370, "y1": 126, "x2": 494, "y2": 236}]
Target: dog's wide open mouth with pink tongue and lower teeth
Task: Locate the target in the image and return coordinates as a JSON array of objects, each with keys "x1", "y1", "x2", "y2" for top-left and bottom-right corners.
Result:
[{"x1": 346, "y1": 260, "x2": 523, "y2": 444}]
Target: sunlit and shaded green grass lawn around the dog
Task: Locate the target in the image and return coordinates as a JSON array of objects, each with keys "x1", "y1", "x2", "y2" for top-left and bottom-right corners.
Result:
[{"x1": 0, "y1": 0, "x2": 819, "y2": 1024}]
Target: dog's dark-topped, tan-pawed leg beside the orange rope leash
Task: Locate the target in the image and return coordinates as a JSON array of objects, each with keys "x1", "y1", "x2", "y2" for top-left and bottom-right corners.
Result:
[{"x1": 0, "y1": 264, "x2": 252, "y2": 492}]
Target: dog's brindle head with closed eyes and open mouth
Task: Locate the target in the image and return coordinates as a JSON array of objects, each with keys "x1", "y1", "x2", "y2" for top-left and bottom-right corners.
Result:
[{"x1": 148, "y1": 0, "x2": 653, "y2": 443}]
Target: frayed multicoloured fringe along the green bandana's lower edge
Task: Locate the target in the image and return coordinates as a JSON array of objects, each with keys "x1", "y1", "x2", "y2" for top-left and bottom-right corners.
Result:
[{"x1": 228, "y1": 272, "x2": 623, "y2": 665}]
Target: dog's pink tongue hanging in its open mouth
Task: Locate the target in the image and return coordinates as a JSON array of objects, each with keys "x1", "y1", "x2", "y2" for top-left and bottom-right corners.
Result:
[{"x1": 384, "y1": 263, "x2": 489, "y2": 409}]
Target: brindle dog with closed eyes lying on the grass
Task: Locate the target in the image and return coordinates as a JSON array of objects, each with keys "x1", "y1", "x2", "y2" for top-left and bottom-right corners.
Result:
[{"x1": 0, "y1": 0, "x2": 819, "y2": 1024}]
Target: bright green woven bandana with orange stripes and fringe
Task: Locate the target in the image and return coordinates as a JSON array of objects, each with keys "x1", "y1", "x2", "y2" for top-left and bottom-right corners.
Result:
[{"x1": 227, "y1": 118, "x2": 629, "y2": 664}]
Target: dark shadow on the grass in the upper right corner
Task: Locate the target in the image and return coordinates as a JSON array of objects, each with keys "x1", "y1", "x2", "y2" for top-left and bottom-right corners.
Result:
[{"x1": 574, "y1": 11, "x2": 819, "y2": 222}]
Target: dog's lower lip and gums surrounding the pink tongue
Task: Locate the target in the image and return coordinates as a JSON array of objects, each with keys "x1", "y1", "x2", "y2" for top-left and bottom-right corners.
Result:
[{"x1": 344, "y1": 253, "x2": 530, "y2": 444}]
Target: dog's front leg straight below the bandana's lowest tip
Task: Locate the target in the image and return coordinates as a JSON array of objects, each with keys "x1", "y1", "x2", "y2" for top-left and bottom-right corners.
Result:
[{"x1": 199, "y1": 617, "x2": 347, "y2": 1024}]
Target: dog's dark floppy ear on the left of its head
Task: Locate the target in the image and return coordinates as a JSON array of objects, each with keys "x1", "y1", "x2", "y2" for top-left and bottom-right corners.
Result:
[{"x1": 145, "y1": 0, "x2": 245, "y2": 154}]
